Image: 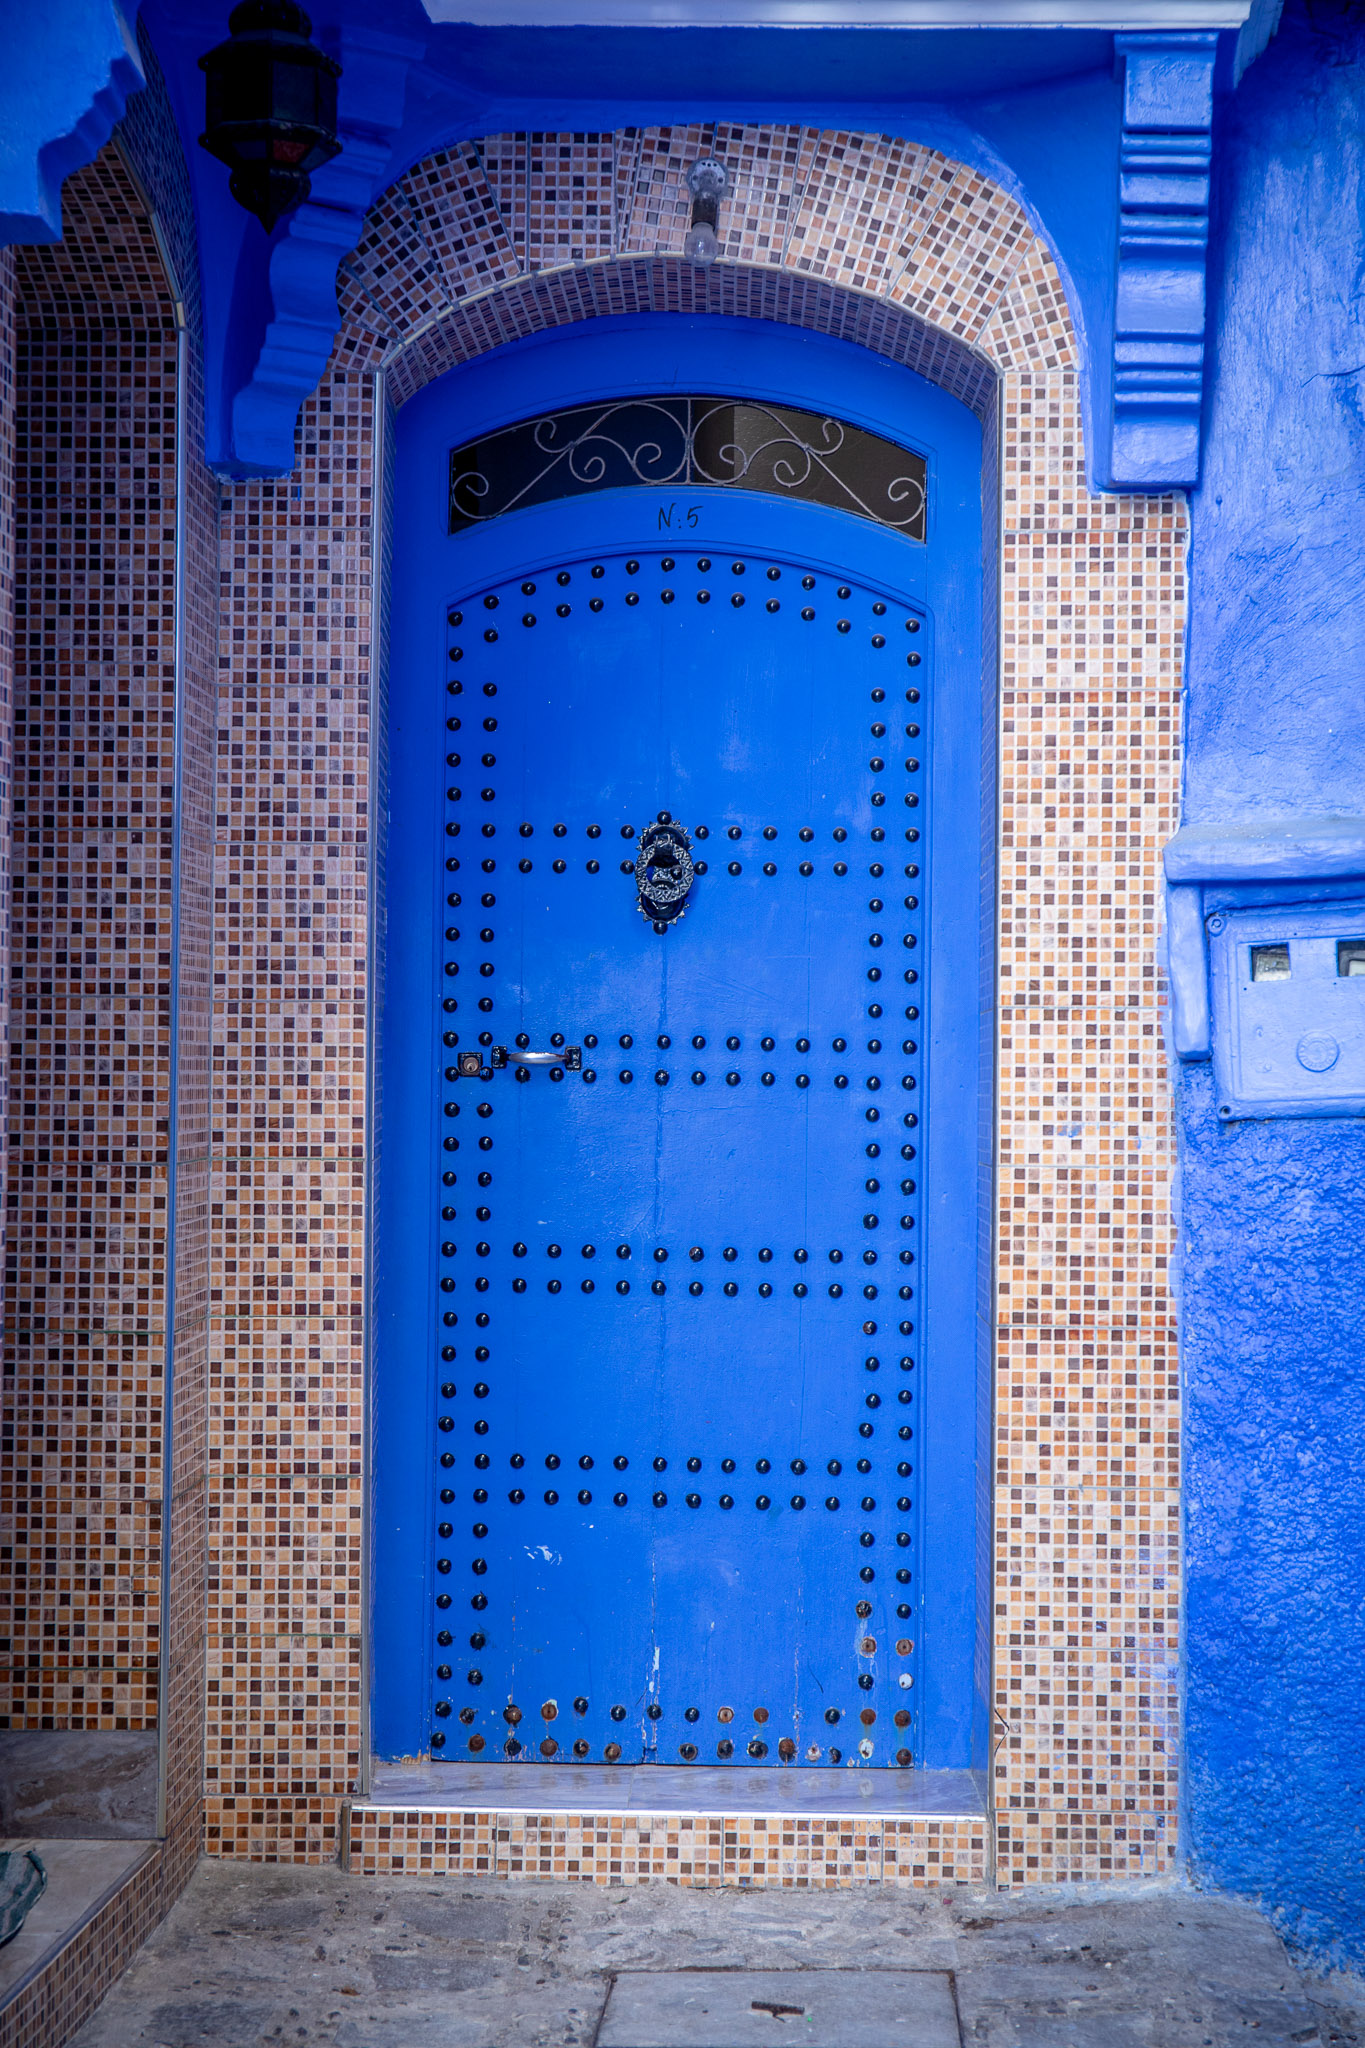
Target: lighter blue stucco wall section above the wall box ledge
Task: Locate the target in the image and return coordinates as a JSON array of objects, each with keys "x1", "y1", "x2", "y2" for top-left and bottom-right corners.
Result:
[{"x1": 1185, "y1": 0, "x2": 1365, "y2": 823}]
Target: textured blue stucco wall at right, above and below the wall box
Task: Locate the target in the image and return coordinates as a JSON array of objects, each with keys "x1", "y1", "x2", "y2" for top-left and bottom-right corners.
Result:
[{"x1": 1179, "y1": 4, "x2": 1365, "y2": 1968}]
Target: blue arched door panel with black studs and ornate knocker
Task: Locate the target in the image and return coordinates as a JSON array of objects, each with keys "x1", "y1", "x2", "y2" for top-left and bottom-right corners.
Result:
[{"x1": 377, "y1": 307, "x2": 994, "y2": 1767}]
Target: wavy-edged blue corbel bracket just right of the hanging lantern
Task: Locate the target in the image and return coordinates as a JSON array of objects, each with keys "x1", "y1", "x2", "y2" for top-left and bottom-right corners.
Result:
[{"x1": 224, "y1": 29, "x2": 424, "y2": 477}]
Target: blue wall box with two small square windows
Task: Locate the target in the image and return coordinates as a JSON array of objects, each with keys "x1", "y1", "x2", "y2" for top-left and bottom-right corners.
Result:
[{"x1": 1205, "y1": 901, "x2": 1365, "y2": 1120}]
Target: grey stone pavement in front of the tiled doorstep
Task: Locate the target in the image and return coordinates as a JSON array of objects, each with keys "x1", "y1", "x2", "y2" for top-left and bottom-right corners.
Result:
[{"x1": 76, "y1": 1862, "x2": 1365, "y2": 2048}]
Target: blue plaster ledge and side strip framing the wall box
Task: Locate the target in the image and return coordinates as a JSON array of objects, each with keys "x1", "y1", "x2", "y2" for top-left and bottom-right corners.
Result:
[{"x1": 1164, "y1": 817, "x2": 1365, "y2": 1059}]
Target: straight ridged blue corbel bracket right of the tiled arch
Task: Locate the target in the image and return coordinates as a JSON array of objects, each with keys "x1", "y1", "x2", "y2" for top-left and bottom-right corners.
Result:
[{"x1": 1105, "y1": 31, "x2": 1218, "y2": 492}]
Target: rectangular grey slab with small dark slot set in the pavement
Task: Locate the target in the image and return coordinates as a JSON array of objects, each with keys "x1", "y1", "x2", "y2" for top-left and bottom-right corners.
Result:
[{"x1": 598, "y1": 1970, "x2": 960, "y2": 2048}]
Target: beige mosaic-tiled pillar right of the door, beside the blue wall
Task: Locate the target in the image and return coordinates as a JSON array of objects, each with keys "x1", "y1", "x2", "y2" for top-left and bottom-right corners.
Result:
[{"x1": 997, "y1": 373, "x2": 1185, "y2": 1882}]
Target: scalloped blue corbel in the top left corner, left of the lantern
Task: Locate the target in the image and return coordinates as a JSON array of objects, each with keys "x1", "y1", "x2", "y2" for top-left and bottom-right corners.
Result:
[{"x1": 0, "y1": 0, "x2": 145, "y2": 242}]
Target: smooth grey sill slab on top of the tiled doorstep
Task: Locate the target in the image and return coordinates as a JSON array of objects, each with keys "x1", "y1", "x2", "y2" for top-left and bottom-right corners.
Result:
[{"x1": 352, "y1": 1761, "x2": 986, "y2": 1819}]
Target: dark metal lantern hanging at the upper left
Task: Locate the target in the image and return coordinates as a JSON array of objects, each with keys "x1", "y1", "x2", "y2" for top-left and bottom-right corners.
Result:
[{"x1": 199, "y1": 0, "x2": 342, "y2": 233}]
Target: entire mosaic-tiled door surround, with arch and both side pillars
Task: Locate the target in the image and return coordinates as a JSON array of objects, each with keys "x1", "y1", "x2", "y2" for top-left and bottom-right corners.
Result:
[{"x1": 207, "y1": 125, "x2": 1185, "y2": 1882}]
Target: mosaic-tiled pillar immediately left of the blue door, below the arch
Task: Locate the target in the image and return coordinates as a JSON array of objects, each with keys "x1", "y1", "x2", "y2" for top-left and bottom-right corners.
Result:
[{"x1": 205, "y1": 372, "x2": 375, "y2": 1862}]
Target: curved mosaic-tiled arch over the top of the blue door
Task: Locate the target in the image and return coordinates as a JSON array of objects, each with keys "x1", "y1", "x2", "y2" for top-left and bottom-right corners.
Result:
[{"x1": 340, "y1": 127, "x2": 1074, "y2": 412}]
